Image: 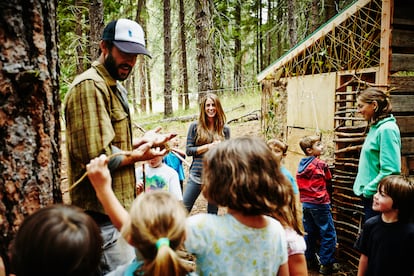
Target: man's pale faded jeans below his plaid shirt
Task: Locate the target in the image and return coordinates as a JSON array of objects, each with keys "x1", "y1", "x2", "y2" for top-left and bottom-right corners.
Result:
[{"x1": 99, "y1": 223, "x2": 135, "y2": 275}]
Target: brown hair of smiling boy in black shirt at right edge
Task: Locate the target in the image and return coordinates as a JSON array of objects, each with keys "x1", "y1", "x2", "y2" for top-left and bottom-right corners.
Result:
[{"x1": 378, "y1": 175, "x2": 414, "y2": 222}]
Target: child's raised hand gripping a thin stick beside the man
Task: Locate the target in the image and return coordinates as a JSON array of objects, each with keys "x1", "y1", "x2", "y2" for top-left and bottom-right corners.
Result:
[{"x1": 86, "y1": 154, "x2": 112, "y2": 192}]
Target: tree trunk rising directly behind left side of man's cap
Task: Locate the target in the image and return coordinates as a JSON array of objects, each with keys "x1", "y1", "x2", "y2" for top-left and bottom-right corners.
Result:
[{"x1": 89, "y1": 0, "x2": 104, "y2": 61}]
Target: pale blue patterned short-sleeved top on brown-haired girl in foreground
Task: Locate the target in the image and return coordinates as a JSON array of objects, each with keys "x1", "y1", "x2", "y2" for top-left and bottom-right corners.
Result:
[{"x1": 185, "y1": 214, "x2": 288, "y2": 276}]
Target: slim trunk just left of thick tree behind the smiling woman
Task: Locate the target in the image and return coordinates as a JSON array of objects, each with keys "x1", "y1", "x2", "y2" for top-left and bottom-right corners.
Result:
[{"x1": 178, "y1": 0, "x2": 190, "y2": 110}]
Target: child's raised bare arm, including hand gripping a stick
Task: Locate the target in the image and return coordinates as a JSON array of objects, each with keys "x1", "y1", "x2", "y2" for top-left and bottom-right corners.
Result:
[{"x1": 86, "y1": 154, "x2": 129, "y2": 230}]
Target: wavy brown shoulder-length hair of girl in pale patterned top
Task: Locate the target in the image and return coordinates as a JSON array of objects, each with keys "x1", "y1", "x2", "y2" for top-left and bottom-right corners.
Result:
[{"x1": 202, "y1": 137, "x2": 291, "y2": 215}]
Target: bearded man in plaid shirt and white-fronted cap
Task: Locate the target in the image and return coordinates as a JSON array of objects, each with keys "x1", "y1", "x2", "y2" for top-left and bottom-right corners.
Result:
[{"x1": 65, "y1": 19, "x2": 175, "y2": 274}]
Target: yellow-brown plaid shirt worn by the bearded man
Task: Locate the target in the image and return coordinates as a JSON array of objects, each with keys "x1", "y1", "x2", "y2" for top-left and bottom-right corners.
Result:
[{"x1": 65, "y1": 61, "x2": 136, "y2": 213}]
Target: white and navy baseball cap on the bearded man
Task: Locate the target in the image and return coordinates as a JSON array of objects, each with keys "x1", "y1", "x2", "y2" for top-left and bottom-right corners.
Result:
[{"x1": 102, "y1": 18, "x2": 151, "y2": 57}]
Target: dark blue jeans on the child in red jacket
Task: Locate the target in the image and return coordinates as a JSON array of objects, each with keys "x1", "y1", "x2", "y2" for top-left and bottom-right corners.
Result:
[{"x1": 303, "y1": 202, "x2": 336, "y2": 265}]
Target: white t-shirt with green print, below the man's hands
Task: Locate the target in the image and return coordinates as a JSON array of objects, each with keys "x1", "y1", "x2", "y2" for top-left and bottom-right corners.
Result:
[{"x1": 135, "y1": 163, "x2": 183, "y2": 200}]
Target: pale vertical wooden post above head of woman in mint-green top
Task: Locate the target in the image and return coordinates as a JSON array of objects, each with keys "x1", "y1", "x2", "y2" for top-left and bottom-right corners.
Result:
[{"x1": 376, "y1": 0, "x2": 392, "y2": 85}]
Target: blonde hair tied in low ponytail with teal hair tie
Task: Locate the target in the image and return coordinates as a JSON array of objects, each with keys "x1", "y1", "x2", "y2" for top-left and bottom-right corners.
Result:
[{"x1": 122, "y1": 190, "x2": 190, "y2": 276}]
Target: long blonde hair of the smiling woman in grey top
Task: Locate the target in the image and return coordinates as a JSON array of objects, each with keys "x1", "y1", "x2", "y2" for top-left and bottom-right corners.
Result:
[{"x1": 196, "y1": 93, "x2": 226, "y2": 145}]
